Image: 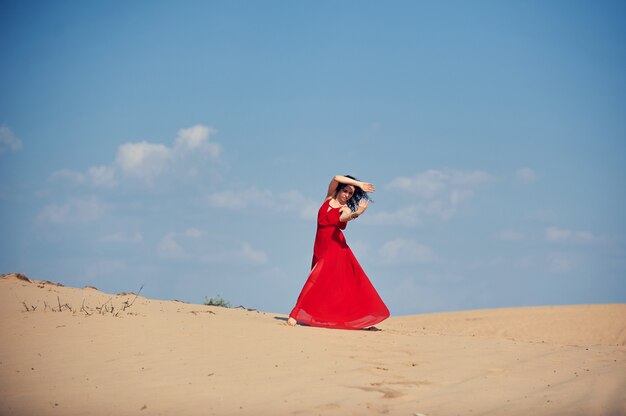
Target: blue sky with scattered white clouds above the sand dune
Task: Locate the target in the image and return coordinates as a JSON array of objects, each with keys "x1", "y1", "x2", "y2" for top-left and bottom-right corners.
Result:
[{"x1": 0, "y1": 1, "x2": 626, "y2": 314}]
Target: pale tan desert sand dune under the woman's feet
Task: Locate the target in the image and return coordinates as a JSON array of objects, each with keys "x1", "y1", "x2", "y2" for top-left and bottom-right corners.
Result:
[{"x1": 0, "y1": 275, "x2": 626, "y2": 416}]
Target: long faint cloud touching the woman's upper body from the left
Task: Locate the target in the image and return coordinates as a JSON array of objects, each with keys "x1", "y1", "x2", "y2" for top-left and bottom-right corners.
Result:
[{"x1": 207, "y1": 187, "x2": 318, "y2": 219}]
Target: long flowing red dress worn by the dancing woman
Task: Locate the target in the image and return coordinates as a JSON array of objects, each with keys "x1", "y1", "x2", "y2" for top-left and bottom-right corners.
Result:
[{"x1": 289, "y1": 198, "x2": 389, "y2": 329}]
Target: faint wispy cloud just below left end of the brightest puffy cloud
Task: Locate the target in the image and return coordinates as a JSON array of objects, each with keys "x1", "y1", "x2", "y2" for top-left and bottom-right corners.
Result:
[{"x1": 38, "y1": 197, "x2": 106, "y2": 224}]
